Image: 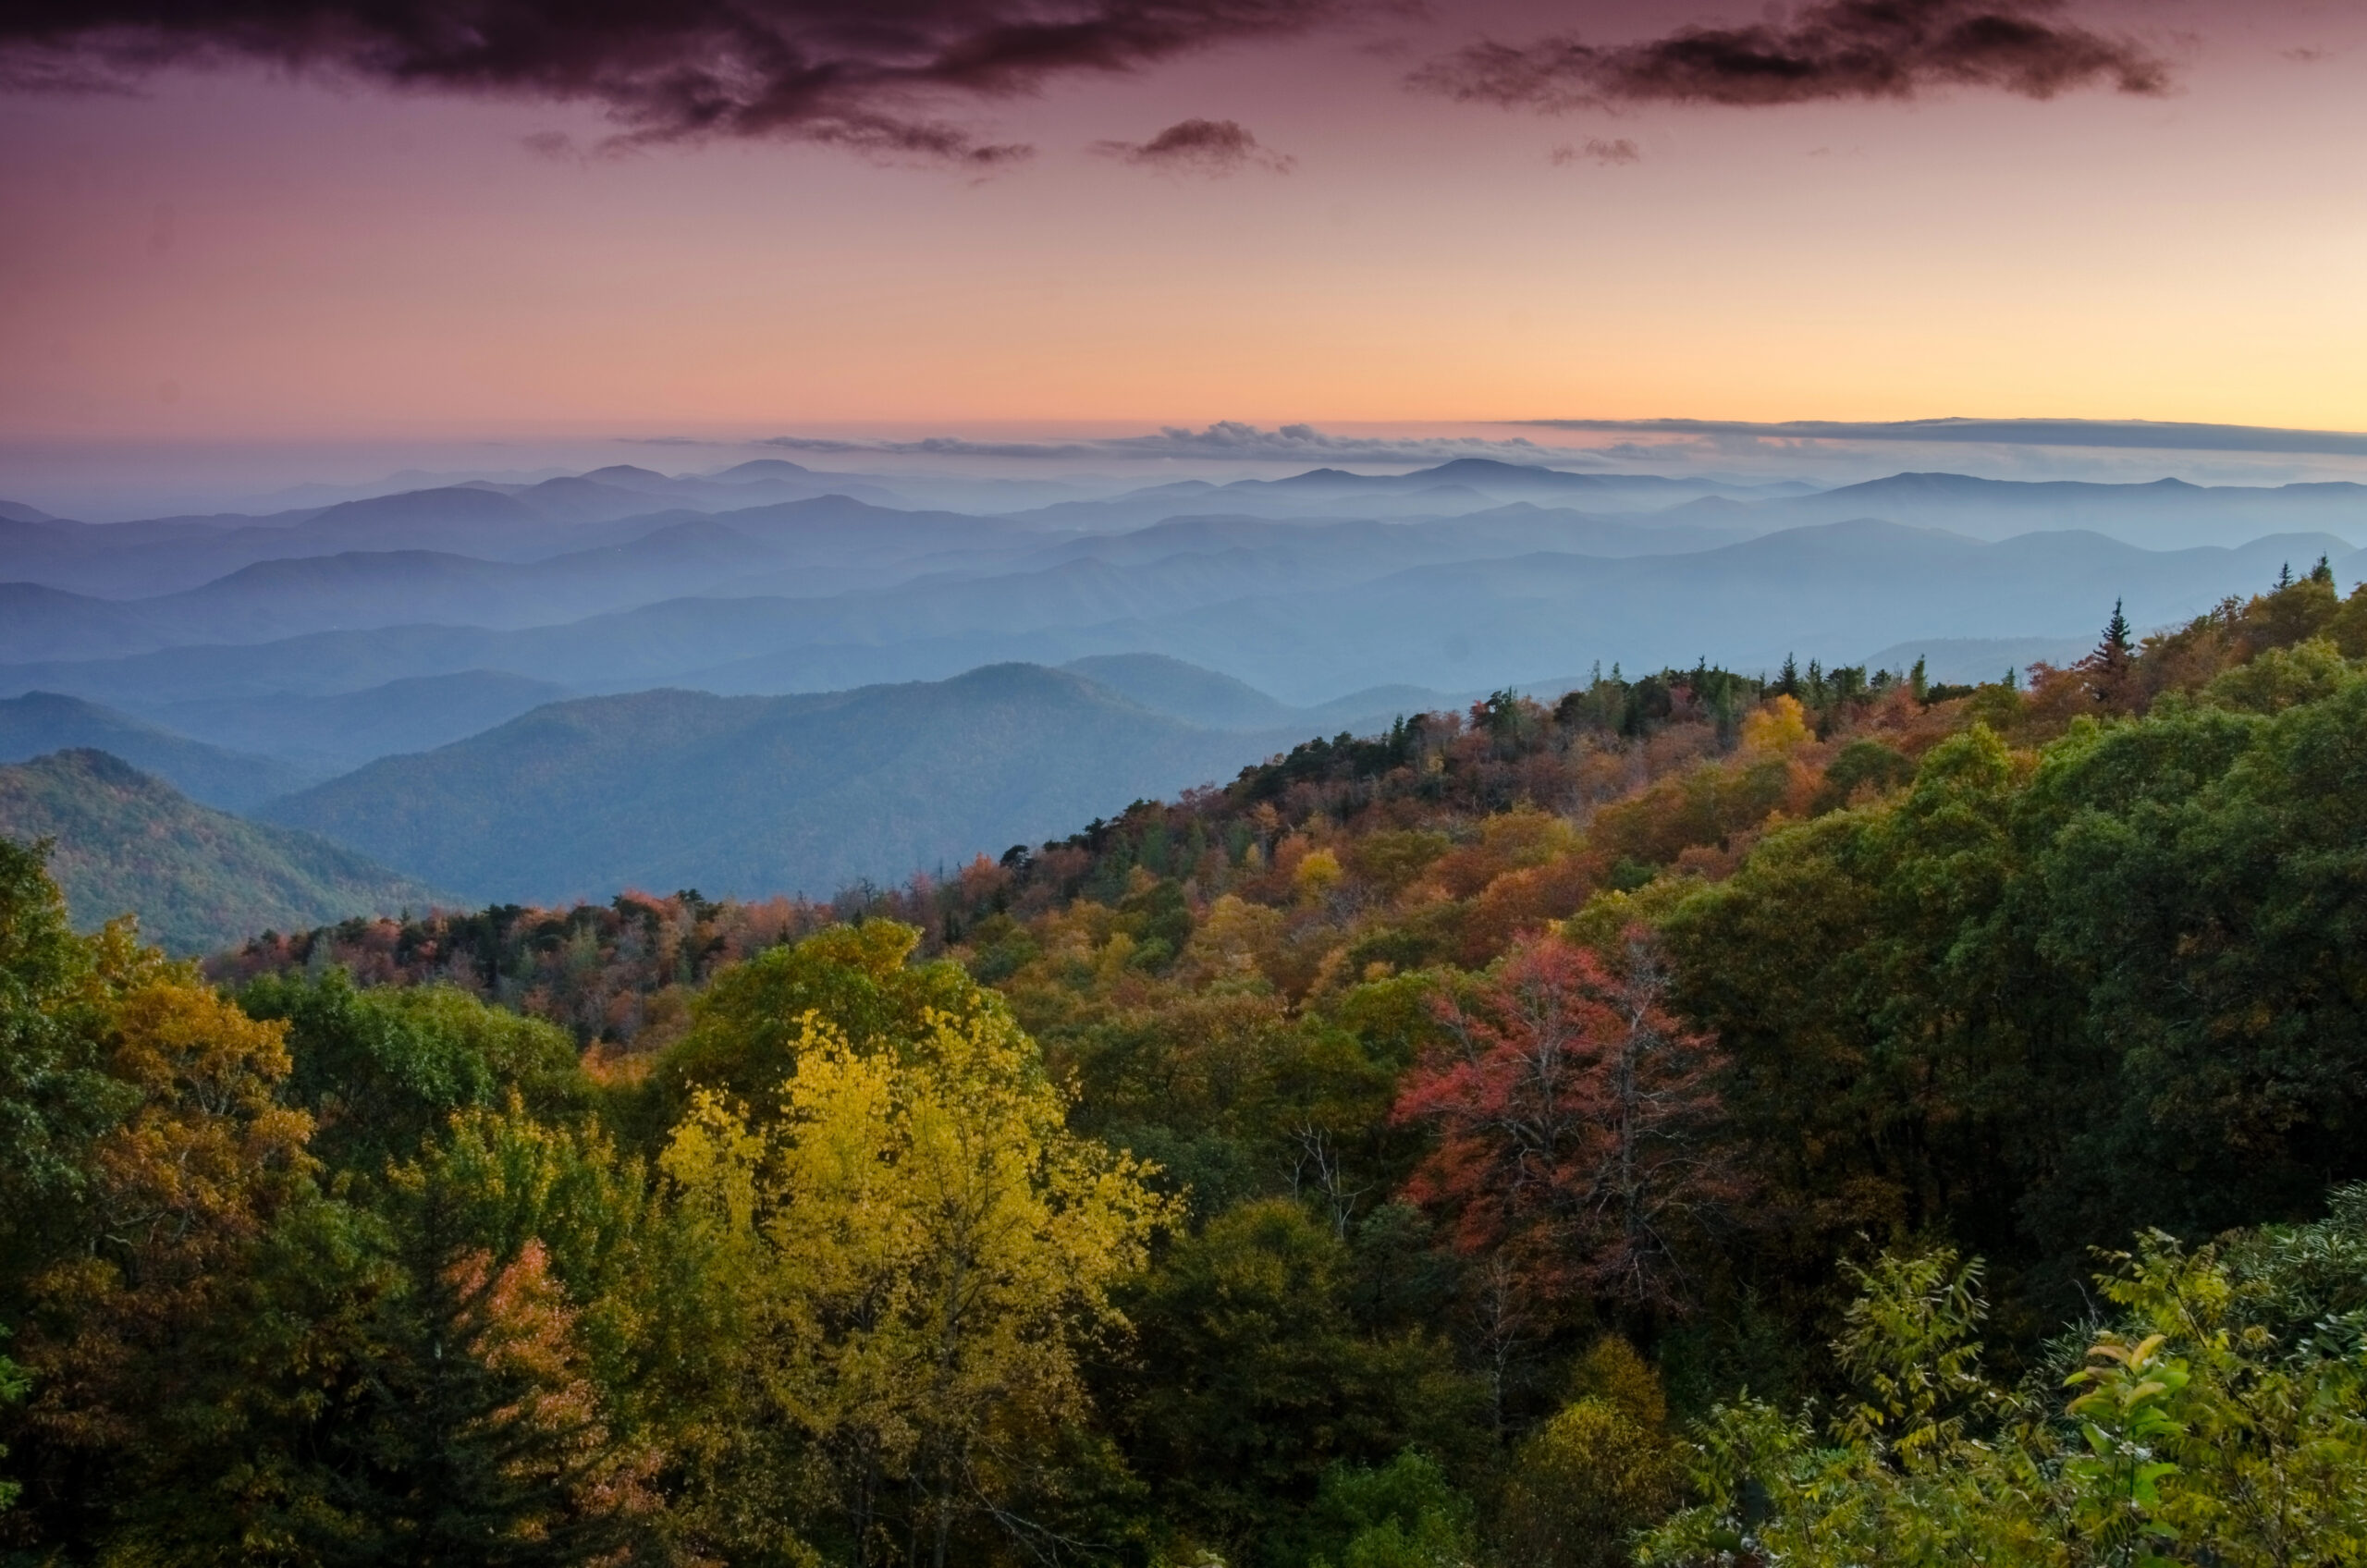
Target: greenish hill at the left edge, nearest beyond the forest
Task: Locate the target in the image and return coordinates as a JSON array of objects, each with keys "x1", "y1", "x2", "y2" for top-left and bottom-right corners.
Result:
[{"x1": 0, "y1": 751, "x2": 433, "y2": 952}]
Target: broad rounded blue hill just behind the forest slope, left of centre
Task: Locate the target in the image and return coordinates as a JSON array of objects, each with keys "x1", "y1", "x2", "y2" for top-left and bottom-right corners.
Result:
[{"x1": 267, "y1": 666, "x2": 1299, "y2": 900}]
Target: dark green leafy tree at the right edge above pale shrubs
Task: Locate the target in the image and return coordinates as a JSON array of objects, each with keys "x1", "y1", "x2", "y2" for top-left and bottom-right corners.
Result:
[{"x1": 2012, "y1": 677, "x2": 2367, "y2": 1251}]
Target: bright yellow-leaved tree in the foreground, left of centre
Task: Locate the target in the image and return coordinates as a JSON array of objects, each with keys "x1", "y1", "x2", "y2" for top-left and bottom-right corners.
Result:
[{"x1": 663, "y1": 1009, "x2": 1174, "y2": 1568}]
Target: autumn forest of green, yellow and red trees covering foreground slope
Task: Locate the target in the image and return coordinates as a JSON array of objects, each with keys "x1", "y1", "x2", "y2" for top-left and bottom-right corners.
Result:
[{"x1": 0, "y1": 564, "x2": 2367, "y2": 1568}]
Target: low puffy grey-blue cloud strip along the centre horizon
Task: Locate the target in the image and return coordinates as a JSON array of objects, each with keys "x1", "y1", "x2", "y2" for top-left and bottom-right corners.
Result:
[{"x1": 757, "y1": 419, "x2": 1598, "y2": 469}]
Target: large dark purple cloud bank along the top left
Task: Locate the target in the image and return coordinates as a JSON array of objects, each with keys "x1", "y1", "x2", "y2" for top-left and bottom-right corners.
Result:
[{"x1": 0, "y1": 0, "x2": 1354, "y2": 165}]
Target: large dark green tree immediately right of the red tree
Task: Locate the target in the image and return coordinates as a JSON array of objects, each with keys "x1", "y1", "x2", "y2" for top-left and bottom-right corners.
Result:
[{"x1": 1660, "y1": 725, "x2": 2054, "y2": 1307}]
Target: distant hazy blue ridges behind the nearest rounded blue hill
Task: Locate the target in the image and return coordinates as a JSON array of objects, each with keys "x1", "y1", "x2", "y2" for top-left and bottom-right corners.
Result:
[{"x1": 0, "y1": 455, "x2": 2367, "y2": 777}]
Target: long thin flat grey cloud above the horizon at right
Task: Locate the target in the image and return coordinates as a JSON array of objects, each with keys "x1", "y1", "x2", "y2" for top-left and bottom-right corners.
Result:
[{"x1": 1520, "y1": 419, "x2": 2367, "y2": 457}]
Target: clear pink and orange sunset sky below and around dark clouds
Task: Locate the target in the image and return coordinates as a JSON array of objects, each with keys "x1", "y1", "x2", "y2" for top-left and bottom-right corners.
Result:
[{"x1": 0, "y1": 0, "x2": 2367, "y2": 438}]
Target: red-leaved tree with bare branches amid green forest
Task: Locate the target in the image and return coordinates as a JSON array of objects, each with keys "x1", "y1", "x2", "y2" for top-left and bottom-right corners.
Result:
[{"x1": 1396, "y1": 931, "x2": 1745, "y2": 1310}]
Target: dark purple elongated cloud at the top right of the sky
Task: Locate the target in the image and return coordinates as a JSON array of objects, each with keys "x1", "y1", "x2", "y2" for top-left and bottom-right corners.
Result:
[{"x1": 1408, "y1": 0, "x2": 2171, "y2": 111}]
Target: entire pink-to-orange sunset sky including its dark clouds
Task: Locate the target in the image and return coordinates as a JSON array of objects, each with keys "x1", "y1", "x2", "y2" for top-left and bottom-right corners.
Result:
[{"x1": 0, "y1": 0, "x2": 2367, "y2": 507}]
